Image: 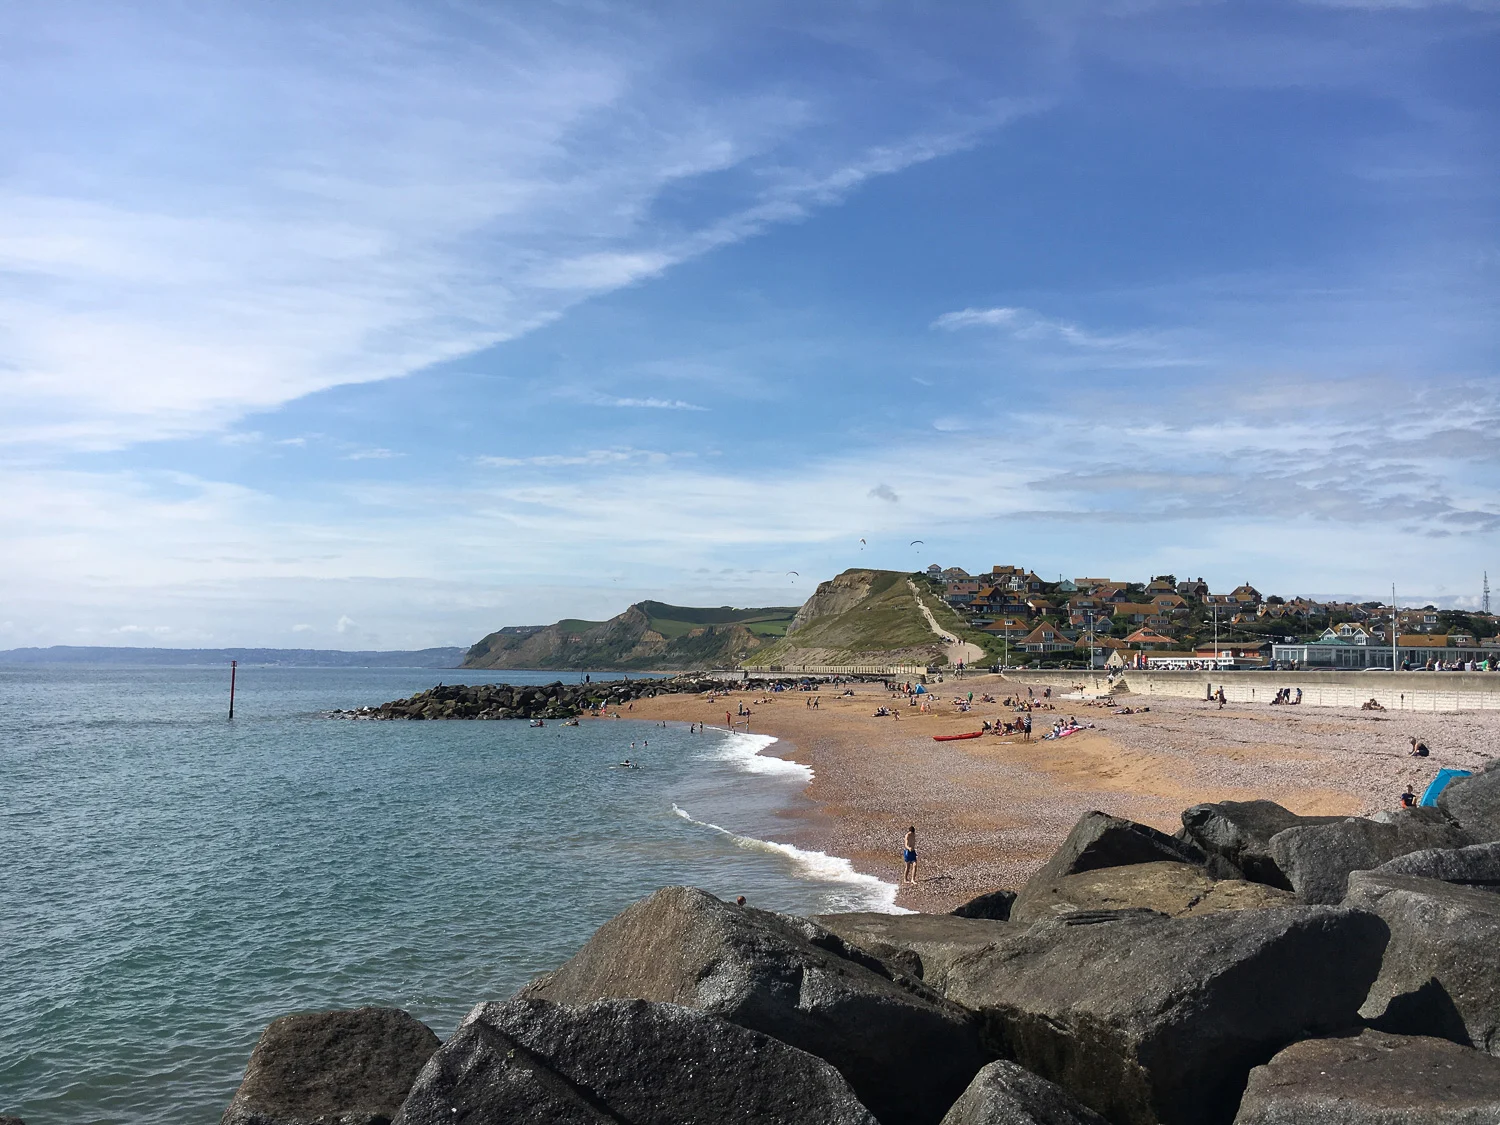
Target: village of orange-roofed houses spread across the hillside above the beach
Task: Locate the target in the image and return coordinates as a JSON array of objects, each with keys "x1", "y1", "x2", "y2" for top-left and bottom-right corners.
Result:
[{"x1": 923, "y1": 564, "x2": 1500, "y2": 669}]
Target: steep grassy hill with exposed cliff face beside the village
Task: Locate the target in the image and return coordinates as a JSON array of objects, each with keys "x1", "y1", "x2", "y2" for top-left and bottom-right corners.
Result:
[{"x1": 744, "y1": 570, "x2": 947, "y2": 668}]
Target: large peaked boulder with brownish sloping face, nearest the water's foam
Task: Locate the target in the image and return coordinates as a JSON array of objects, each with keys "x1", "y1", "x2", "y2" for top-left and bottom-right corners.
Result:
[{"x1": 521, "y1": 887, "x2": 989, "y2": 1125}]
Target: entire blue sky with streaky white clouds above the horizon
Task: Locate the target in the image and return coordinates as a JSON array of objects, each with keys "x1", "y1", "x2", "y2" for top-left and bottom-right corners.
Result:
[{"x1": 0, "y1": 0, "x2": 1500, "y2": 648}]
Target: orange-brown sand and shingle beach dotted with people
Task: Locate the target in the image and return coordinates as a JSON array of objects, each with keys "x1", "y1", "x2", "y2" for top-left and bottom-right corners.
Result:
[{"x1": 630, "y1": 674, "x2": 1500, "y2": 911}]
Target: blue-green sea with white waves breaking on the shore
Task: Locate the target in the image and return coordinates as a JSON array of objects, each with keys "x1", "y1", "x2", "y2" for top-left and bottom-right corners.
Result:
[{"x1": 0, "y1": 665, "x2": 896, "y2": 1125}]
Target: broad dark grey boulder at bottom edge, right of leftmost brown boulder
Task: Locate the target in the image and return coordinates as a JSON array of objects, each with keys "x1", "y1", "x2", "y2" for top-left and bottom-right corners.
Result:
[{"x1": 396, "y1": 1001, "x2": 878, "y2": 1125}]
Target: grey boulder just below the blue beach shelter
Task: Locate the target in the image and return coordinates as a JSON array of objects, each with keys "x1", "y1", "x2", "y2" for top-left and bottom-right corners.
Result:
[{"x1": 1271, "y1": 809, "x2": 1472, "y2": 905}]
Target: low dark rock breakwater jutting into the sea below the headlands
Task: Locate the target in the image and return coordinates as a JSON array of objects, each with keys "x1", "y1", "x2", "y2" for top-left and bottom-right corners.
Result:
[{"x1": 330, "y1": 677, "x2": 743, "y2": 719}]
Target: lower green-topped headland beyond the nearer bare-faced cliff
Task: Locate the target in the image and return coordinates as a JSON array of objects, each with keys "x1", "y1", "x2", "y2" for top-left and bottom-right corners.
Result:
[{"x1": 464, "y1": 602, "x2": 797, "y2": 671}]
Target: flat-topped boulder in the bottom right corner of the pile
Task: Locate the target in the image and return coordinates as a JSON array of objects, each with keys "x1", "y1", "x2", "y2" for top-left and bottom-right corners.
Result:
[{"x1": 1235, "y1": 1031, "x2": 1500, "y2": 1125}]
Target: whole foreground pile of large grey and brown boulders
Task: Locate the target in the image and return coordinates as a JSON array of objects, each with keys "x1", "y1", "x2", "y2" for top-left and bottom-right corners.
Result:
[{"x1": 225, "y1": 761, "x2": 1500, "y2": 1125}]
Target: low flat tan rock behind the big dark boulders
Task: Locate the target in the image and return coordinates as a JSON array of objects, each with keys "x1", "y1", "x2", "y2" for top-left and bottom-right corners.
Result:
[{"x1": 1011, "y1": 861, "x2": 1296, "y2": 924}]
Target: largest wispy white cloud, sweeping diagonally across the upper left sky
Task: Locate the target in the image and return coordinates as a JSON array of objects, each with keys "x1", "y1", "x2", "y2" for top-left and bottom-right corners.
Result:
[{"x1": 0, "y1": 2, "x2": 1028, "y2": 449}]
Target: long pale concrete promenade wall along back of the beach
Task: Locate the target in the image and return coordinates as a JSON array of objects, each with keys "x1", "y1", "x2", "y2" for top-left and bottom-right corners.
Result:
[{"x1": 1005, "y1": 669, "x2": 1500, "y2": 711}]
